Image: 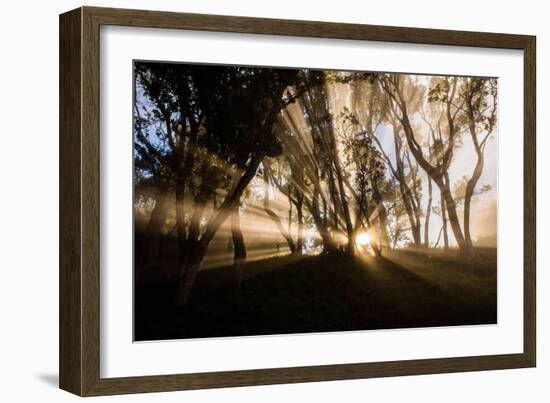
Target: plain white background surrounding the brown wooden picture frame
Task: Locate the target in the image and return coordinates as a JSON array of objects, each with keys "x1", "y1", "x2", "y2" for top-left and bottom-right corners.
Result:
[{"x1": 0, "y1": 0, "x2": 550, "y2": 403}]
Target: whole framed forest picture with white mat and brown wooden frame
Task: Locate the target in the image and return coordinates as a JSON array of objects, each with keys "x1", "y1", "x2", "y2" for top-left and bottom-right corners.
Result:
[{"x1": 60, "y1": 7, "x2": 536, "y2": 396}]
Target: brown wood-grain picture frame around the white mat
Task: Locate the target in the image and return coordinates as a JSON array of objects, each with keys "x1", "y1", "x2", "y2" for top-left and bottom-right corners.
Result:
[{"x1": 59, "y1": 7, "x2": 536, "y2": 396}]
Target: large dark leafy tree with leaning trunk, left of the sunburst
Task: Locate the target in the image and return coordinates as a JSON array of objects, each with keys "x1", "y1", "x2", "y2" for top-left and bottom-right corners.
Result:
[{"x1": 136, "y1": 63, "x2": 314, "y2": 305}]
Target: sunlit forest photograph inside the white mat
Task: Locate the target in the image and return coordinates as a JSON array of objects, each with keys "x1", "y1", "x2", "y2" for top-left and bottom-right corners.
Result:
[{"x1": 134, "y1": 60, "x2": 500, "y2": 342}]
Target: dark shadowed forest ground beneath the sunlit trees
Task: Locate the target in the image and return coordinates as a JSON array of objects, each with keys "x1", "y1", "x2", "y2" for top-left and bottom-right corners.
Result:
[{"x1": 134, "y1": 249, "x2": 497, "y2": 341}]
